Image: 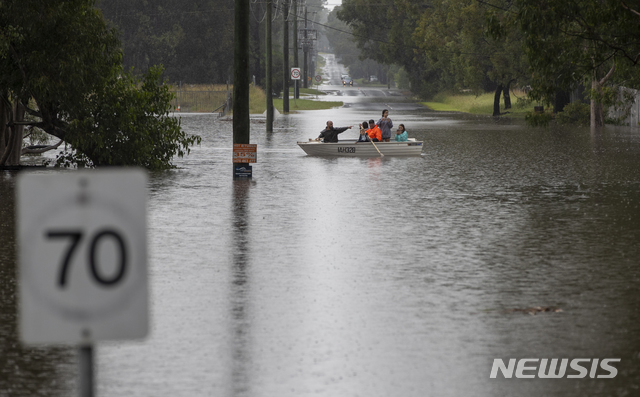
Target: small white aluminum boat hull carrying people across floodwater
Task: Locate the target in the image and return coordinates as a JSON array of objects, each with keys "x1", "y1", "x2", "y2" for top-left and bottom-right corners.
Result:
[{"x1": 298, "y1": 138, "x2": 422, "y2": 157}]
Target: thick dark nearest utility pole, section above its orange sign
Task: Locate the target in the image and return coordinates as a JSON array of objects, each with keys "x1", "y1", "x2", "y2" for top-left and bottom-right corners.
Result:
[{"x1": 233, "y1": 0, "x2": 251, "y2": 144}]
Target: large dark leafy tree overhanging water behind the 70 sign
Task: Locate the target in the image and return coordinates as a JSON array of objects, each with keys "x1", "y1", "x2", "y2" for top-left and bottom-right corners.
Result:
[{"x1": 0, "y1": 0, "x2": 199, "y2": 169}]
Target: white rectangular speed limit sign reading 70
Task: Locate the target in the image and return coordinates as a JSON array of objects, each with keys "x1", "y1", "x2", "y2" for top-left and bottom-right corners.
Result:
[{"x1": 16, "y1": 170, "x2": 148, "y2": 344}]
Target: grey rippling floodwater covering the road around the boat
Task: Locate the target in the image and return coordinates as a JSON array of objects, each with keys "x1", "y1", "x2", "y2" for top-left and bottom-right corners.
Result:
[{"x1": 0, "y1": 87, "x2": 640, "y2": 397}]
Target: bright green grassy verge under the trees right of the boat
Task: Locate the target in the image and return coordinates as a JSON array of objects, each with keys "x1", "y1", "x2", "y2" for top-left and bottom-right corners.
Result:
[{"x1": 421, "y1": 92, "x2": 533, "y2": 118}]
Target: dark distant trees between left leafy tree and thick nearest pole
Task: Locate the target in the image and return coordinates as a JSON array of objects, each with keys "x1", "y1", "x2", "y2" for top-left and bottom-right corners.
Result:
[{"x1": 98, "y1": 0, "x2": 235, "y2": 84}]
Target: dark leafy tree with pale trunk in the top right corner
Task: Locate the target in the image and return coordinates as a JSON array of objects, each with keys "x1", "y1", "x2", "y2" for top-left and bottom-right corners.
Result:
[{"x1": 503, "y1": 0, "x2": 640, "y2": 127}]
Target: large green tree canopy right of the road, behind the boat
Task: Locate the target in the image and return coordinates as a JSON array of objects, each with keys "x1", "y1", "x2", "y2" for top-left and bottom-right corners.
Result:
[{"x1": 338, "y1": 0, "x2": 527, "y2": 114}]
